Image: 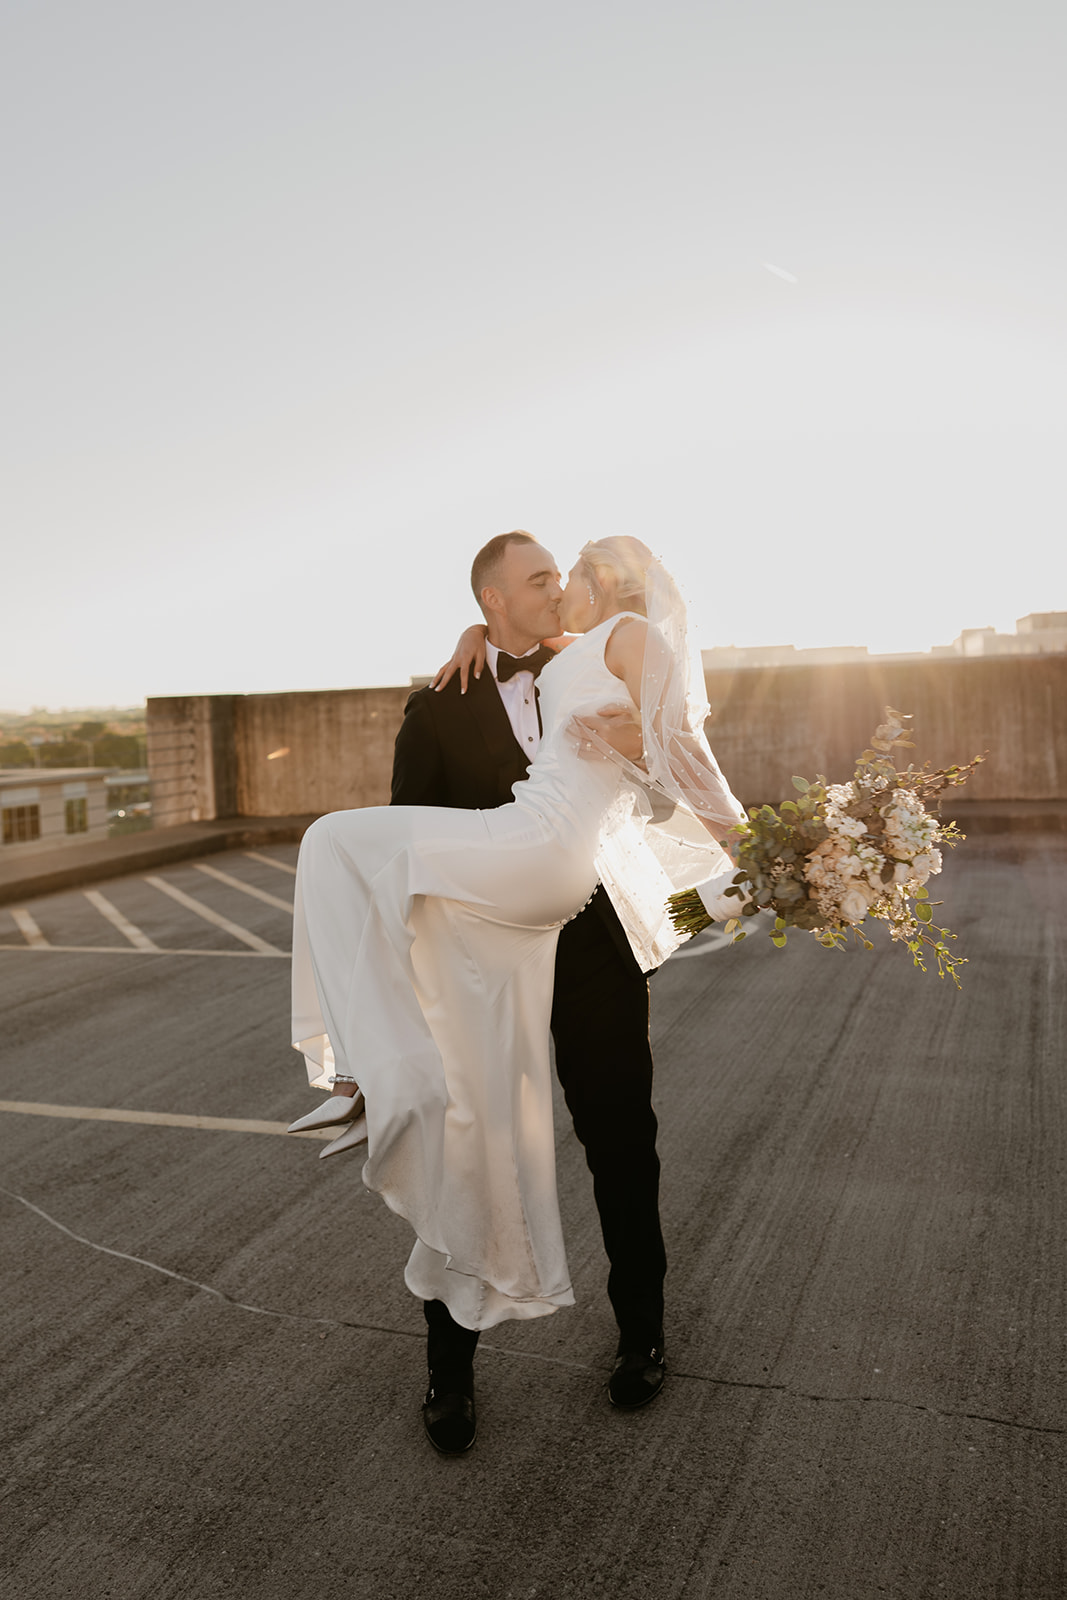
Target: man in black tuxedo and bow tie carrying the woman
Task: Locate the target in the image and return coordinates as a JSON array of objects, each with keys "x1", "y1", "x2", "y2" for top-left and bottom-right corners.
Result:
[{"x1": 392, "y1": 531, "x2": 667, "y2": 1454}]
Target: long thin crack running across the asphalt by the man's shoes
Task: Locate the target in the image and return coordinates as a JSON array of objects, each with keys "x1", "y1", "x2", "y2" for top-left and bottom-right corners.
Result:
[{"x1": 0, "y1": 1184, "x2": 1067, "y2": 1435}]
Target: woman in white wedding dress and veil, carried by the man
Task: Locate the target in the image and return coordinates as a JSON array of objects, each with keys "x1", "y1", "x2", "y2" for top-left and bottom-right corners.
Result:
[{"x1": 291, "y1": 538, "x2": 744, "y2": 1330}]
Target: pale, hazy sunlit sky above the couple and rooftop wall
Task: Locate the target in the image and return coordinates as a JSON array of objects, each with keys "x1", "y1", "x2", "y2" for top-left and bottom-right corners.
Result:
[{"x1": 0, "y1": 0, "x2": 1067, "y2": 710}]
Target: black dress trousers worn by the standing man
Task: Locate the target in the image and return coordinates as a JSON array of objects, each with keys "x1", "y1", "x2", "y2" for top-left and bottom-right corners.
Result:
[{"x1": 424, "y1": 890, "x2": 667, "y2": 1373}]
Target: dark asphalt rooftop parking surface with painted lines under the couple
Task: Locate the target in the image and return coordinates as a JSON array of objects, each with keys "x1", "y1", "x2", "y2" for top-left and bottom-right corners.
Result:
[{"x1": 0, "y1": 835, "x2": 1067, "y2": 1600}]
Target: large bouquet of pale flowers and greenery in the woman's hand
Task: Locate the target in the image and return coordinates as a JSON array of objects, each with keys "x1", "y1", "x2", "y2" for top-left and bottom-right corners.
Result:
[{"x1": 669, "y1": 706, "x2": 985, "y2": 989}]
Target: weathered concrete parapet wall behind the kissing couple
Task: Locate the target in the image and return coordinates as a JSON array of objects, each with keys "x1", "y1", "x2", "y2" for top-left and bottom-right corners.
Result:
[{"x1": 147, "y1": 654, "x2": 1067, "y2": 826}]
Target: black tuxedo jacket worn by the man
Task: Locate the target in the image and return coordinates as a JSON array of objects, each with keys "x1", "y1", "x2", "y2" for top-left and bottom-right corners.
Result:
[{"x1": 390, "y1": 666, "x2": 640, "y2": 981}]
